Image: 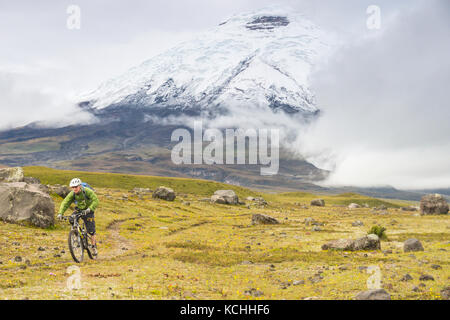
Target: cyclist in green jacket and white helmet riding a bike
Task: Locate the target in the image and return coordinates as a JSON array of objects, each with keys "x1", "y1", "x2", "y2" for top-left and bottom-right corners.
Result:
[{"x1": 58, "y1": 178, "x2": 98, "y2": 255}]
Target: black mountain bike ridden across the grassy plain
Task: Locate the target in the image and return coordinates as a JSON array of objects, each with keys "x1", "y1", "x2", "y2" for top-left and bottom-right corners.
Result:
[{"x1": 63, "y1": 210, "x2": 97, "y2": 263}]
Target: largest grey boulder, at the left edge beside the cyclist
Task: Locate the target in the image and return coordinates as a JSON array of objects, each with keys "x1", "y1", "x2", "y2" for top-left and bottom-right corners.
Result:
[{"x1": 0, "y1": 182, "x2": 55, "y2": 228}]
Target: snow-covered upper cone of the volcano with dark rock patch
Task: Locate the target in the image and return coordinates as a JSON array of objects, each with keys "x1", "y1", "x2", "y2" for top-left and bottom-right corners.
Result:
[{"x1": 82, "y1": 8, "x2": 327, "y2": 114}]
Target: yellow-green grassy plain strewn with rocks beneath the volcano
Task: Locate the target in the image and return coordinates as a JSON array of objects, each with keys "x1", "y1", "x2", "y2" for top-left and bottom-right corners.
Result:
[{"x1": 0, "y1": 170, "x2": 450, "y2": 300}]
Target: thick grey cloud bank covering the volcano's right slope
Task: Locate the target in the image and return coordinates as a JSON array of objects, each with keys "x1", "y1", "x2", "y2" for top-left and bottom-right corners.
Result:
[{"x1": 297, "y1": 1, "x2": 450, "y2": 189}]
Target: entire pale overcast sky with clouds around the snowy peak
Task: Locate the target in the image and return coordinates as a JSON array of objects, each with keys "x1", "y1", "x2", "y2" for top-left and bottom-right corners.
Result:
[{"x1": 0, "y1": 0, "x2": 450, "y2": 188}]
